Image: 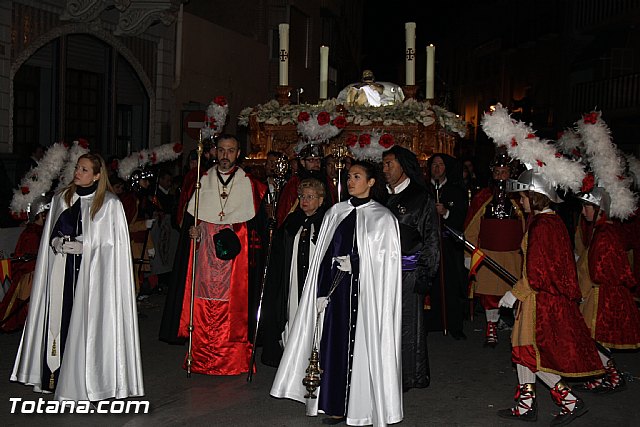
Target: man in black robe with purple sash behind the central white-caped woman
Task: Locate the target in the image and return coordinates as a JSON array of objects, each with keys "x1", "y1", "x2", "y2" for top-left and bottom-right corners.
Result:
[{"x1": 382, "y1": 145, "x2": 440, "y2": 391}]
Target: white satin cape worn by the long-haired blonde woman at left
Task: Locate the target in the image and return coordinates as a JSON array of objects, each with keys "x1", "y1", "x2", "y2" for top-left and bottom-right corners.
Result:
[{"x1": 11, "y1": 192, "x2": 144, "y2": 401}]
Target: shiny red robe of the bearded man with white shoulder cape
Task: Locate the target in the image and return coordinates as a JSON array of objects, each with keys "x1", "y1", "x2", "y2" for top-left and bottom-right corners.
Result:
[{"x1": 178, "y1": 175, "x2": 267, "y2": 375}]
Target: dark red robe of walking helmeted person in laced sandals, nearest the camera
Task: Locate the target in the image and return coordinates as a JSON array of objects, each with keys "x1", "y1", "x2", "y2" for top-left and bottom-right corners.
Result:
[{"x1": 512, "y1": 213, "x2": 604, "y2": 377}]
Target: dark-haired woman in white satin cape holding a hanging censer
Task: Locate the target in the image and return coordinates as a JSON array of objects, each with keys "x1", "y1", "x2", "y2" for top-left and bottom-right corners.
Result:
[{"x1": 271, "y1": 162, "x2": 403, "y2": 425}]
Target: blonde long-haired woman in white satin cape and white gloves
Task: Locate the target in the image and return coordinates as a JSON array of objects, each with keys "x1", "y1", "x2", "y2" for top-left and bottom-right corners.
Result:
[{"x1": 11, "y1": 153, "x2": 144, "y2": 401}]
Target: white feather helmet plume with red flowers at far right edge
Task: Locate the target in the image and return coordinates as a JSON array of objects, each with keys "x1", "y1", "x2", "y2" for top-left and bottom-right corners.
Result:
[{"x1": 576, "y1": 111, "x2": 637, "y2": 219}]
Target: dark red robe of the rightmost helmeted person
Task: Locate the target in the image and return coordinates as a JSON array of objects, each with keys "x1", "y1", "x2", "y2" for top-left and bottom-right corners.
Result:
[{"x1": 587, "y1": 223, "x2": 640, "y2": 349}]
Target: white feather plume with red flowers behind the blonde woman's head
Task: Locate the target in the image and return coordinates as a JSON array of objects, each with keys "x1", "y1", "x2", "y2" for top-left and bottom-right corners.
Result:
[{"x1": 9, "y1": 139, "x2": 89, "y2": 216}]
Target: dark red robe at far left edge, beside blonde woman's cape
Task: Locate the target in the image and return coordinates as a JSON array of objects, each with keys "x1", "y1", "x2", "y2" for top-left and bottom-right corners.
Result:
[{"x1": 0, "y1": 223, "x2": 43, "y2": 332}]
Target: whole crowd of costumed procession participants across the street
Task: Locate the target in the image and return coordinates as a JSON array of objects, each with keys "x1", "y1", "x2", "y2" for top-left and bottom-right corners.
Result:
[{"x1": 5, "y1": 118, "x2": 640, "y2": 425}]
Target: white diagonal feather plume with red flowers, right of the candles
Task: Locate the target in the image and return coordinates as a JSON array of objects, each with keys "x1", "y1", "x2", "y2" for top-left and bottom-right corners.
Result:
[{"x1": 482, "y1": 104, "x2": 585, "y2": 192}]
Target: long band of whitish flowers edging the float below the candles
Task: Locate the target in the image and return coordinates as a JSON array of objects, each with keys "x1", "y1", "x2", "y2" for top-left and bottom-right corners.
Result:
[{"x1": 238, "y1": 98, "x2": 452, "y2": 132}]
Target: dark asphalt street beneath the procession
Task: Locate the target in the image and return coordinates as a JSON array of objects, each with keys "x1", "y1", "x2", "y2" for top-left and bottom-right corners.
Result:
[{"x1": 0, "y1": 295, "x2": 640, "y2": 427}]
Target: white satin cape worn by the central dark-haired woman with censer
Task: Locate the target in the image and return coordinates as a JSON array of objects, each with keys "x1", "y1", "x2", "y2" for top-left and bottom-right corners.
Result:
[{"x1": 271, "y1": 201, "x2": 403, "y2": 426}]
